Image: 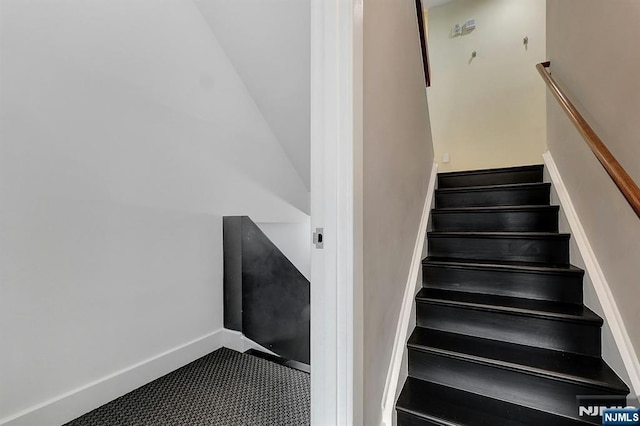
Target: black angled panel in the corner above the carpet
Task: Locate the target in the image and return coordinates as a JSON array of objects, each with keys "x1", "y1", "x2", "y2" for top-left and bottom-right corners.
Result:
[{"x1": 223, "y1": 216, "x2": 311, "y2": 364}]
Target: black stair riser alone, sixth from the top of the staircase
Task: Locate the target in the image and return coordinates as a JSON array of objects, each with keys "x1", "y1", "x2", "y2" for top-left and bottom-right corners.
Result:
[{"x1": 416, "y1": 301, "x2": 601, "y2": 356}]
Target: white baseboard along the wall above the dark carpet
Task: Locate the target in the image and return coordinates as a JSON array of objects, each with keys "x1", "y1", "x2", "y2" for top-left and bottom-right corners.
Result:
[{"x1": 0, "y1": 328, "x2": 272, "y2": 426}]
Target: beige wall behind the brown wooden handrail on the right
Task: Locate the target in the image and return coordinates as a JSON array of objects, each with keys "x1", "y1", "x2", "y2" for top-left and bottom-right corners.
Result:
[{"x1": 547, "y1": 0, "x2": 640, "y2": 386}]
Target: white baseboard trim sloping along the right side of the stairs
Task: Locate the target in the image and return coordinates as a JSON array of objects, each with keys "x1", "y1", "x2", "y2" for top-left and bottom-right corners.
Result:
[{"x1": 542, "y1": 151, "x2": 640, "y2": 395}]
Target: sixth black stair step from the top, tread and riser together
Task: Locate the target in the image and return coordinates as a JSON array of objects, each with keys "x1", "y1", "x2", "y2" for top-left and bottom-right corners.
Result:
[{"x1": 416, "y1": 288, "x2": 602, "y2": 356}]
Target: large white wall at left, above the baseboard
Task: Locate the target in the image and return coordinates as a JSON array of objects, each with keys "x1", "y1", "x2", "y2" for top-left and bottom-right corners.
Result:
[{"x1": 0, "y1": 0, "x2": 309, "y2": 423}]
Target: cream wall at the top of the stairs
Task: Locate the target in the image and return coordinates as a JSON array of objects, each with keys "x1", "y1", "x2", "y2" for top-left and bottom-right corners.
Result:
[{"x1": 427, "y1": 0, "x2": 546, "y2": 172}]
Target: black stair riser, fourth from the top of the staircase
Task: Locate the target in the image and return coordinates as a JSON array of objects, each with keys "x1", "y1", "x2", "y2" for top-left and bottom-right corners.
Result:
[{"x1": 428, "y1": 235, "x2": 569, "y2": 265}]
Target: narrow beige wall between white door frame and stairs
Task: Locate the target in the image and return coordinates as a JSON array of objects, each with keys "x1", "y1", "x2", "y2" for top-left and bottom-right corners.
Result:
[{"x1": 363, "y1": 0, "x2": 433, "y2": 425}]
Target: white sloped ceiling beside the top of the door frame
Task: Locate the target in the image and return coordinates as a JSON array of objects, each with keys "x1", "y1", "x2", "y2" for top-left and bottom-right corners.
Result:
[{"x1": 194, "y1": 0, "x2": 310, "y2": 189}]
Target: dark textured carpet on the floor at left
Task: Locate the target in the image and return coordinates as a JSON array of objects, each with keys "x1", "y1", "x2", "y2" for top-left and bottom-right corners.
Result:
[{"x1": 67, "y1": 348, "x2": 311, "y2": 426}]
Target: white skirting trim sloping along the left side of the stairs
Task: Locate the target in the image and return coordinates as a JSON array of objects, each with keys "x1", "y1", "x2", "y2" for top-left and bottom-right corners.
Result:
[{"x1": 381, "y1": 163, "x2": 438, "y2": 426}]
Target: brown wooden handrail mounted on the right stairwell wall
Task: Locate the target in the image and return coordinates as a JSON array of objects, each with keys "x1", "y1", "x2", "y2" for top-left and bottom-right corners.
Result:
[{"x1": 536, "y1": 61, "x2": 640, "y2": 217}]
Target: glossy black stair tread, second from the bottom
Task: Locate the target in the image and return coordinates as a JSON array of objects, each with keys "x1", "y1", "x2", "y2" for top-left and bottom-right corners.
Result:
[{"x1": 407, "y1": 327, "x2": 629, "y2": 394}]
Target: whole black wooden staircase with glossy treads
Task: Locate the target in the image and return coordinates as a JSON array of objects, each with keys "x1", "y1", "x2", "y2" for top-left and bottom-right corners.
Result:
[{"x1": 396, "y1": 166, "x2": 629, "y2": 426}]
